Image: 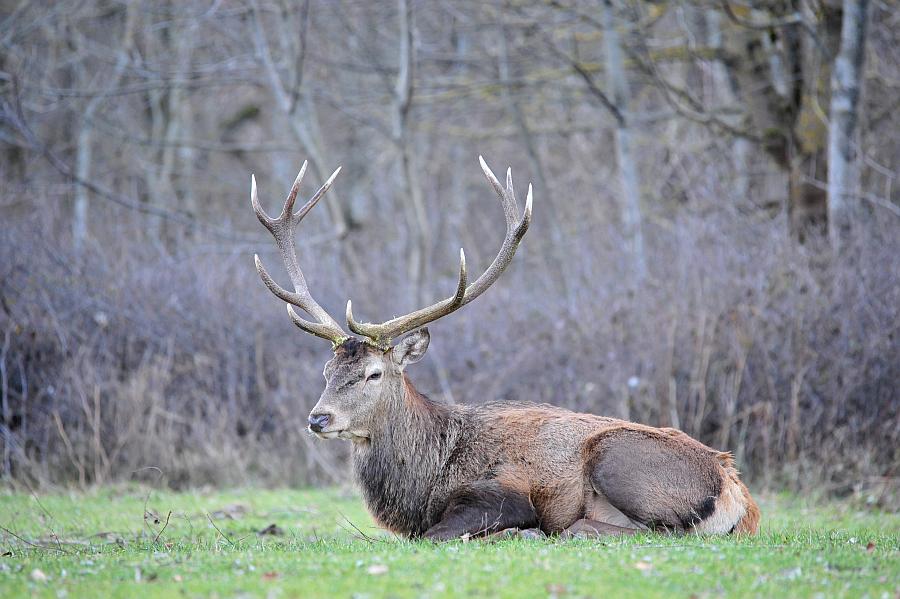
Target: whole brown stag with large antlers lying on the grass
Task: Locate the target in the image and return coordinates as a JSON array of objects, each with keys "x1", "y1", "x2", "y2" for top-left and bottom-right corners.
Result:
[{"x1": 250, "y1": 159, "x2": 759, "y2": 540}]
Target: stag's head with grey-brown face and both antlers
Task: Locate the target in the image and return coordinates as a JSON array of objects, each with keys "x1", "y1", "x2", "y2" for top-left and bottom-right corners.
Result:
[{"x1": 250, "y1": 156, "x2": 531, "y2": 441}]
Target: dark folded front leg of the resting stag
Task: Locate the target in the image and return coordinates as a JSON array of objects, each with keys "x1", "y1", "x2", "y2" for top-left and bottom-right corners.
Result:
[{"x1": 424, "y1": 480, "x2": 538, "y2": 541}]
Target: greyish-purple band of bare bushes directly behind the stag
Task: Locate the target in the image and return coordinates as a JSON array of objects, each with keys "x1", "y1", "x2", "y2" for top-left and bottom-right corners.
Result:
[{"x1": 0, "y1": 199, "x2": 900, "y2": 500}]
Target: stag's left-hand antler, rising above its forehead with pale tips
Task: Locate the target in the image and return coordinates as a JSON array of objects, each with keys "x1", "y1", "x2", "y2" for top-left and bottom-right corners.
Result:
[{"x1": 250, "y1": 161, "x2": 348, "y2": 345}]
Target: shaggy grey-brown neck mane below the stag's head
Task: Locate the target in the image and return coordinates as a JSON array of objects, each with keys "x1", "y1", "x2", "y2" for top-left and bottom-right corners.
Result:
[{"x1": 353, "y1": 374, "x2": 453, "y2": 536}]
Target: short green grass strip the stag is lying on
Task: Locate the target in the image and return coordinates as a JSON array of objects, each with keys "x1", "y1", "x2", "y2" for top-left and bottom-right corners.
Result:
[{"x1": 0, "y1": 488, "x2": 900, "y2": 598}]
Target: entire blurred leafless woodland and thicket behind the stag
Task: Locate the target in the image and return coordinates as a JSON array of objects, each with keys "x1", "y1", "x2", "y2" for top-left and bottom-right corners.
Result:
[{"x1": 0, "y1": 0, "x2": 900, "y2": 503}]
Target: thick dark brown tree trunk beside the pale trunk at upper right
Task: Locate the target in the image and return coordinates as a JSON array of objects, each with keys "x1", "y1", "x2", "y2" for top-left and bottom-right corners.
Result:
[{"x1": 722, "y1": 2, "x2": 840, "y2": 243}]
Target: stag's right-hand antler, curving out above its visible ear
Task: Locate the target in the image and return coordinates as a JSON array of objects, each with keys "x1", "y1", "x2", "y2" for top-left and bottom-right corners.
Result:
[{"x1": 347, "y1": 156, "x2": 531, "y2": 346}]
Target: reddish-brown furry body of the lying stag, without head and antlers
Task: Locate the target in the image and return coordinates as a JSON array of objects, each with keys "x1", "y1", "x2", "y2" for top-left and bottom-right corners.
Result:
[{"x1": 338, "y1": 349, "x2": 758, "y2": 539}]
